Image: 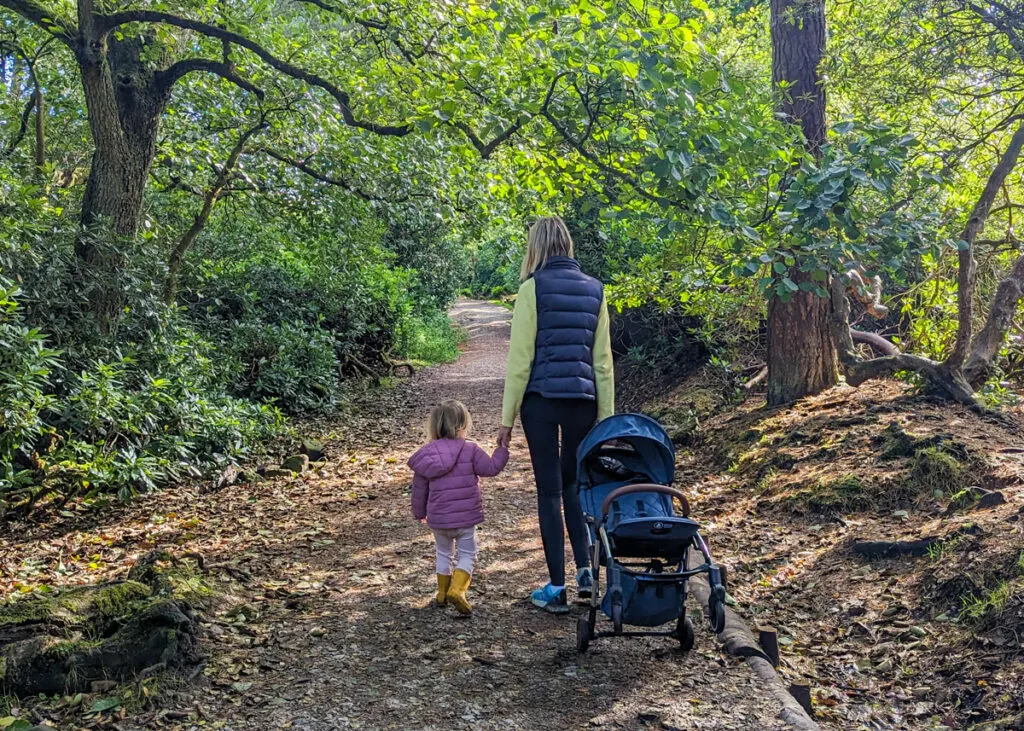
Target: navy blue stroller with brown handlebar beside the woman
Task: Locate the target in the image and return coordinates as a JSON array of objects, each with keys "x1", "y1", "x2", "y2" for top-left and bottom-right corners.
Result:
[{"x1": 577, "y1": 414, "x2": 725, "y2": 652}]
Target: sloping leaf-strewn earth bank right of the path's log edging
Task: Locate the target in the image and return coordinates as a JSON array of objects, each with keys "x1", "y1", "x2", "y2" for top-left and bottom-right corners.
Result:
[{"x1": 650, "y1": 373, "x2": 1024, "y2": 731}]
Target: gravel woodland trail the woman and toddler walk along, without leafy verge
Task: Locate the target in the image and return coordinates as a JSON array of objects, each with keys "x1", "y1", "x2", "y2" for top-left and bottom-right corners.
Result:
[{"x1": 195, "y1": 301, "x2": 779, "y2": 729}]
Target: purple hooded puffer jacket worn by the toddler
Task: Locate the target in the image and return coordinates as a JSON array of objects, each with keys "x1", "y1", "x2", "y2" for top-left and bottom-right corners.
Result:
[{"x1": 409, "y1": 439, "x2": 509, "y2": 528}]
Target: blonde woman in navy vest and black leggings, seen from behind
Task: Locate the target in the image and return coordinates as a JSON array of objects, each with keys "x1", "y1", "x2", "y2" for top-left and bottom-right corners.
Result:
[{"x1": 498, "y1": 217, "x2": 615, "y2": 613}]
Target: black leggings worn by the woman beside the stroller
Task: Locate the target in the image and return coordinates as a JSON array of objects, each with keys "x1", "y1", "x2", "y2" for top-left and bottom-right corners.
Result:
[{"x1": 520, "y1": 393, "x2": 597, "y2": 587}]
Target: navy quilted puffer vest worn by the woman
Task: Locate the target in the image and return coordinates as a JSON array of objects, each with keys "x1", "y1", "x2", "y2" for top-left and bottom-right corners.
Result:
[{"x1": 526, "y1": 256, "x2": 604, "y2": 400}]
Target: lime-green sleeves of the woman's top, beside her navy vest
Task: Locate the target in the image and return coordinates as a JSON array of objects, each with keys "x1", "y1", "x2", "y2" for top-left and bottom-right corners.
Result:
[{"x1": 502, "y1": 280, "x2": 615, "y2": 427}]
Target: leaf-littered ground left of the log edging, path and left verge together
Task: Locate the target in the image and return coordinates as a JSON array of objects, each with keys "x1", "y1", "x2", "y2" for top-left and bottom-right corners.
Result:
[{"x1": 0, "y1": 302, "x2": 782, "y2": 731}]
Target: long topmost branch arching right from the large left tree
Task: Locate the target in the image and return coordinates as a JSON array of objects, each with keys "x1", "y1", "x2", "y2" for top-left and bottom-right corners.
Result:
[{"x1": 97, "y1": 9, "x2": 413, "y2": 137}]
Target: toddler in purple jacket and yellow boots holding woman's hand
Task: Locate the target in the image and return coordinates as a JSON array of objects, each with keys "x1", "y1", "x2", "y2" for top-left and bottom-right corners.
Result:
[{"x1": 409, "y1": 401, "x2": 509, "y2": 614}]
